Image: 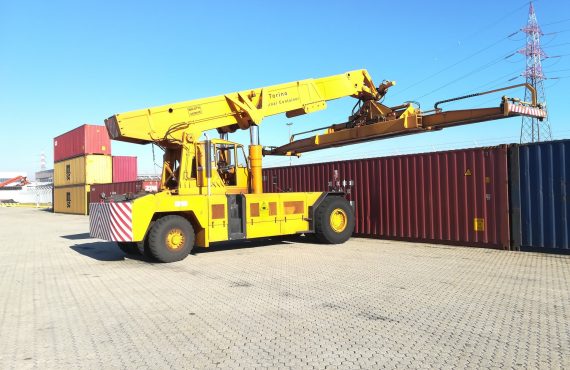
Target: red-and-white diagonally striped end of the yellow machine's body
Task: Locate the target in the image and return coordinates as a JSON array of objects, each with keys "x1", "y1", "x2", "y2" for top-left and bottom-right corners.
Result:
[{"x1": 89, "y1": 202, "x2": 133, "y2": 242}]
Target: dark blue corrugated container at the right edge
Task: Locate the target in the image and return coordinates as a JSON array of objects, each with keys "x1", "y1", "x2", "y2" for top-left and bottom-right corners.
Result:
[{"x1": 509, "y1": 140, "x2": 570, "y2": 251}]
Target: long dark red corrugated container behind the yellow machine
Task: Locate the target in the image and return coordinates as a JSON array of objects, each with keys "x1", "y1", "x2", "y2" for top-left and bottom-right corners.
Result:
[{"x1": 264, "y1": 146, "x2": 510, "y2": 249}]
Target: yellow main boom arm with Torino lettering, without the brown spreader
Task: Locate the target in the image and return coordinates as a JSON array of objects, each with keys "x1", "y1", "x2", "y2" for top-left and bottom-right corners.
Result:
[{"x1": 105, "y1": 69, "x2": 386, "y2": 147}]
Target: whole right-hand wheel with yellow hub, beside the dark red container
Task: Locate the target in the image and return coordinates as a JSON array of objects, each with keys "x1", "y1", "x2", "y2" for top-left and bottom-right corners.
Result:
[{"x1": 315, "y1": 196, "x2": 354, "y2": 244}]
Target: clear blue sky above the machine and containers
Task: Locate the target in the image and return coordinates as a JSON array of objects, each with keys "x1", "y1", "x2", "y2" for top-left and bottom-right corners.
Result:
[{"x1": 0, "y1": 0, "x2": 570, "y2": 175}]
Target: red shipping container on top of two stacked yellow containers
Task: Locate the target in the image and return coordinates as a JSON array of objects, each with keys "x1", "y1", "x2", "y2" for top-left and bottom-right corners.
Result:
[{"x1": 53, "y1": 125, "x2": 111, "y2": 162}]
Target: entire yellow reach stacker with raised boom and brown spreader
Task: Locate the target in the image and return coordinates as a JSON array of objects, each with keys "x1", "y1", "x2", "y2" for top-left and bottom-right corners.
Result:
[{"x1": 90, "y1": 70, "x2": 546, "y2": 262}]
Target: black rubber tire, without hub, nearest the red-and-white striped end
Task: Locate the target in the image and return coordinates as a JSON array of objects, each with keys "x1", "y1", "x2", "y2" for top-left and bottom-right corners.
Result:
[{"x1": 148, "y1": 215, "x2": 195, "y2": 263}]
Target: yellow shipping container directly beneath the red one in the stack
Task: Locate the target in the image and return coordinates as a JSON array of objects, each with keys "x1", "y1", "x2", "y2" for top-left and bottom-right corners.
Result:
[{"x1": 53, "y1": 155, "x2": 113, "y2": 187}]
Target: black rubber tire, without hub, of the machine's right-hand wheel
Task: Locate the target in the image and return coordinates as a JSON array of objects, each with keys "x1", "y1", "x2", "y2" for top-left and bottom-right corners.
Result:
[{"x1": 315, "y1": 196, "x2": 354, "y2": 244}]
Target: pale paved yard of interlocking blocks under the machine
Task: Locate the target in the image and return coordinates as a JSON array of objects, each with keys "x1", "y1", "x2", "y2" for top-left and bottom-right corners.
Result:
[{"x1": 0, "y1": 208, "x2": 570, "y2": 369}]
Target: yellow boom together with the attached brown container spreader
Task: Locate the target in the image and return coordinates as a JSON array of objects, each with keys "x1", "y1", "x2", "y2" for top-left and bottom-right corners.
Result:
[{"x1": 105, "y1": 69, "x2": 546, "y2": 158}]
